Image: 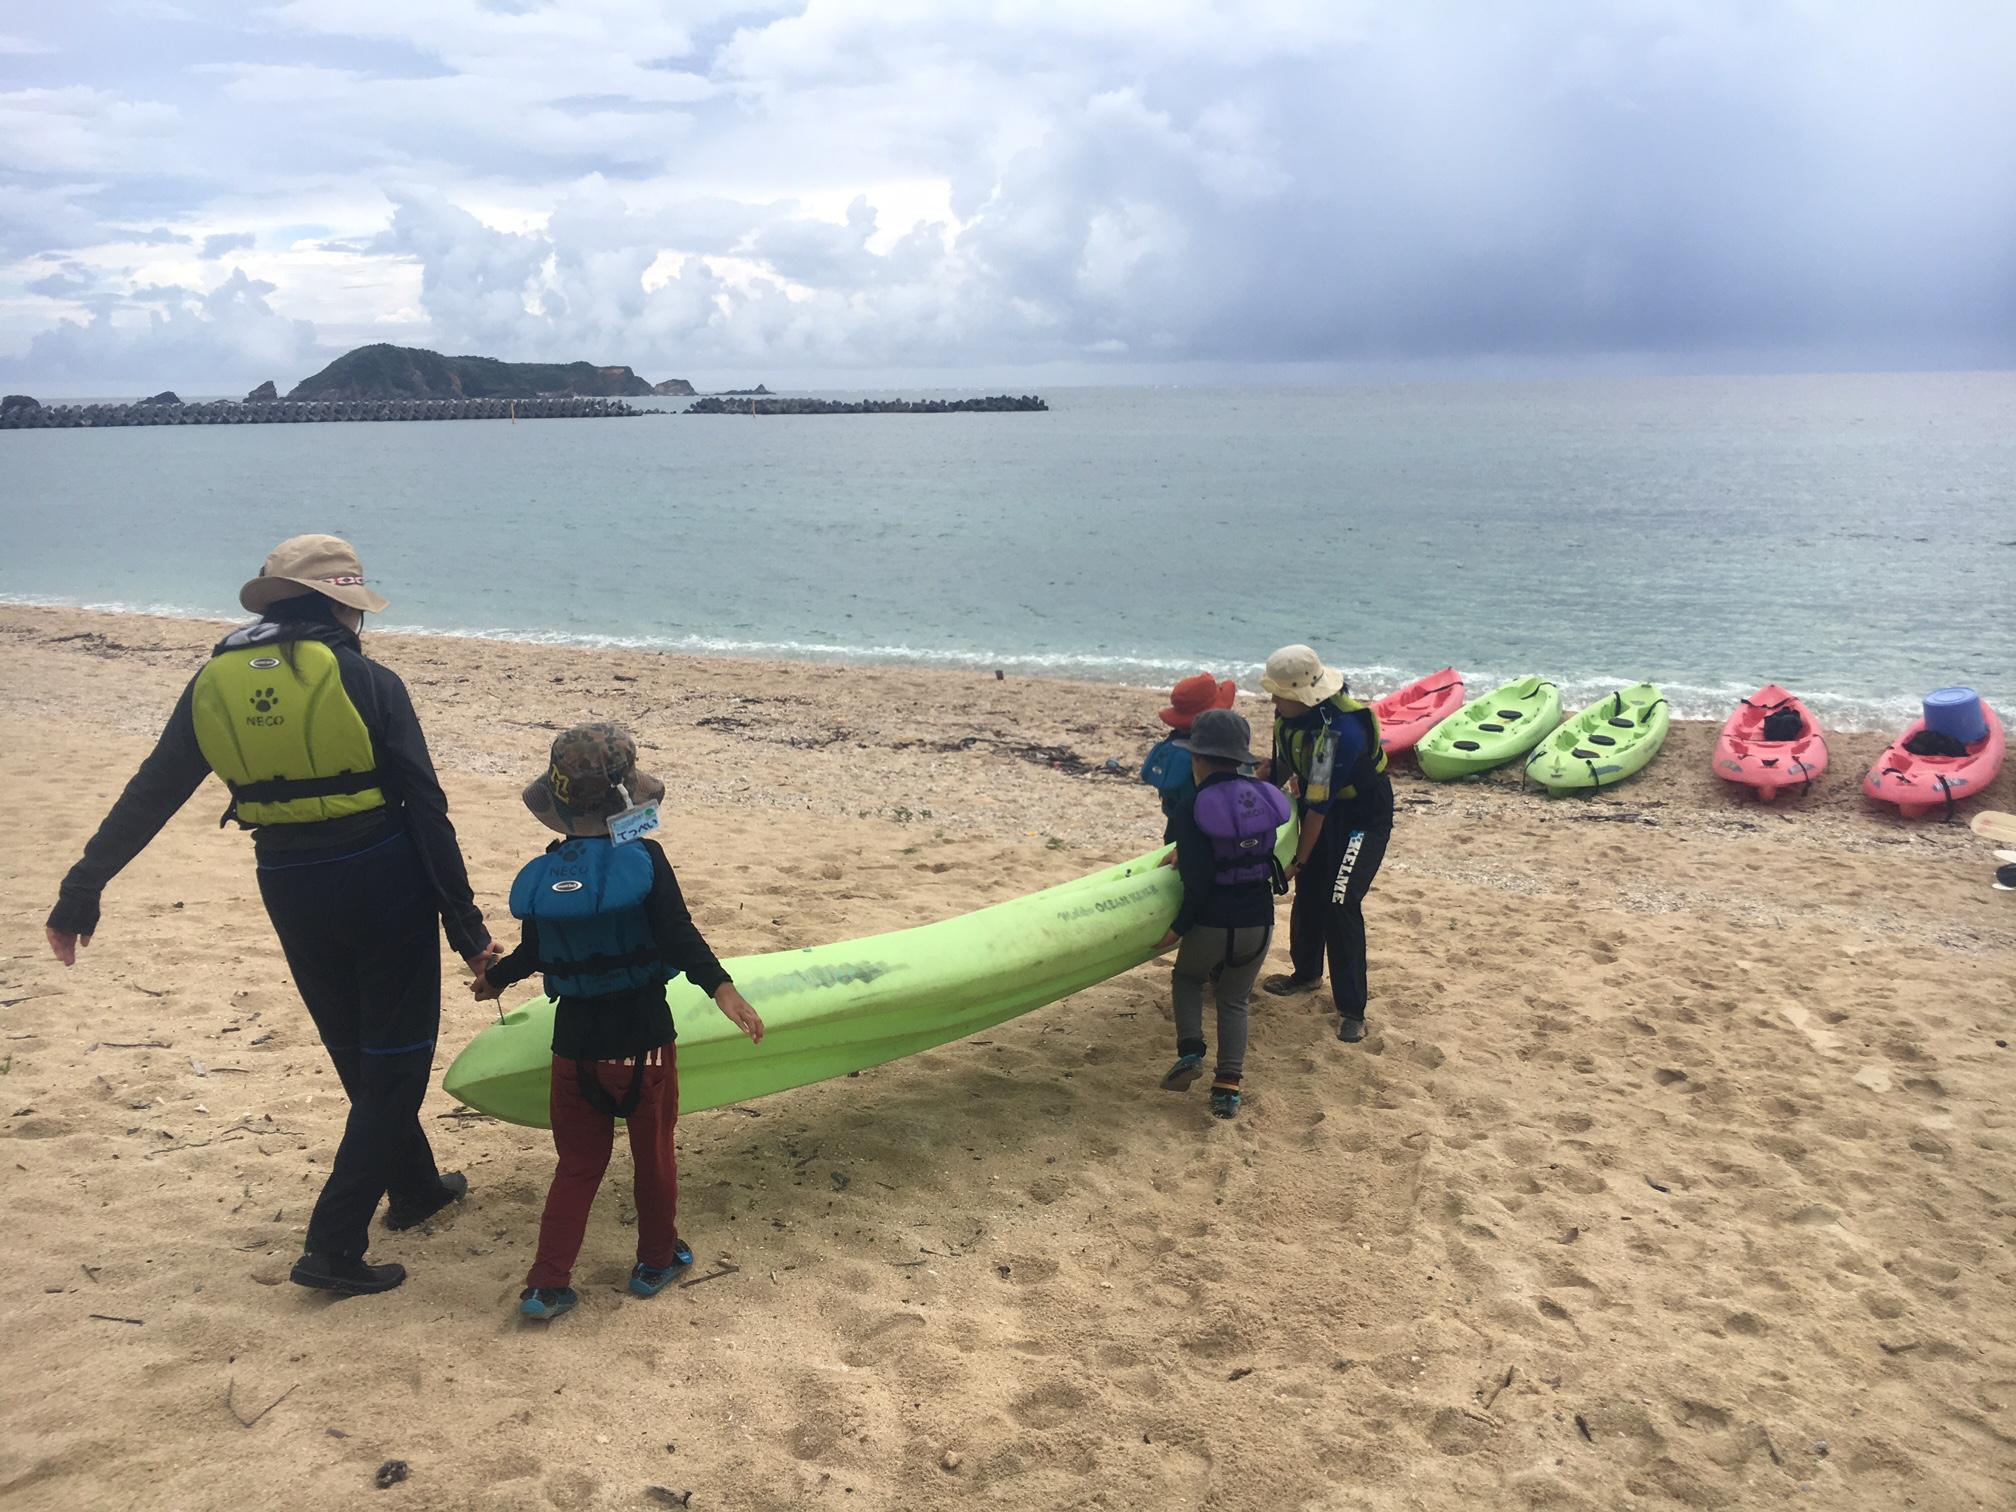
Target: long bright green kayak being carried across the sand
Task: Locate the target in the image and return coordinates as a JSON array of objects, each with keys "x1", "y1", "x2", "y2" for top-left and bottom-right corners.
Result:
[{"x1": 444, "y1": 821, "x2": 1294, "y2": 1129}]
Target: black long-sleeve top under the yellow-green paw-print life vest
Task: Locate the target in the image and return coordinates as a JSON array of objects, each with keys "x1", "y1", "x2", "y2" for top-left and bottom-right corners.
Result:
[{"x1": 48, "y1": 621, "x2": 490, "y2": 956}]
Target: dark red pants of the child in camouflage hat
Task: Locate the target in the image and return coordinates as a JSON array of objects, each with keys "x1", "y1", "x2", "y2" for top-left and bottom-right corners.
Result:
[{"x1": 524, "y1": 1044, "x2": 679, "y2": 1288}]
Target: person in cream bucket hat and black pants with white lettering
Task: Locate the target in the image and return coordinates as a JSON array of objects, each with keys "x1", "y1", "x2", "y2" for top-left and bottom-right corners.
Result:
[{"x1": 1260, "y1": 645, "x2": 1393, "y2": 1044}]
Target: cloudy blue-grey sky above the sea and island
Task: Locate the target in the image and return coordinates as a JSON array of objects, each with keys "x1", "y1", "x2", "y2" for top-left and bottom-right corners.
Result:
[{"x1": 0, "y1": 0, "x2": 2016, "y2": 395}]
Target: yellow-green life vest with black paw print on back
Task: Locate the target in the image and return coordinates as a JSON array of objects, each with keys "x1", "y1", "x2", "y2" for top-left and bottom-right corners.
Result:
[{"x1": 190, "y1": 637, "x2": 385, "y2": 827}]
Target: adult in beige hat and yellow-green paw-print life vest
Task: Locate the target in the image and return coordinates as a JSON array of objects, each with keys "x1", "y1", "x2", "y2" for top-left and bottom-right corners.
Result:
[{"x1": 44, "y1": 536, "x2": 502, "y2": 1294}]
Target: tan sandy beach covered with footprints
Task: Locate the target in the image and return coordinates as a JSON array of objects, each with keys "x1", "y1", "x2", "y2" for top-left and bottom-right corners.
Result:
[{"x1": 0, "y1": 607, "x2": 2016, "y2": 1512}]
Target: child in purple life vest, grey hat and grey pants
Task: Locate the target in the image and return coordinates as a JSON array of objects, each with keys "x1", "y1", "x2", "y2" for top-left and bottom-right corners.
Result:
[{"x1": 1159, "y1": 710, "x2": 1290, "y2": 1119}]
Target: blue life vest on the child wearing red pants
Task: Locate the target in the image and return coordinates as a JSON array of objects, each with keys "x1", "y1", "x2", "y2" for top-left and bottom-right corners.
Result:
[{"x1": 510, "y1": 835, "x2": 671, "y2": 998}]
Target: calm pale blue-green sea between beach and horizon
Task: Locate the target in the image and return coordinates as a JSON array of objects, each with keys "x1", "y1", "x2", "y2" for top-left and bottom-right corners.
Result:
[{"x1": 0, "y1": 373, "x2": 2016, "y2": 726}]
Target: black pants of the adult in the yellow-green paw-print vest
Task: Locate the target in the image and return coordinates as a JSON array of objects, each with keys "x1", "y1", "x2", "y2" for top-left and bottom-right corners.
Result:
[{"x1": 258, "y1": 833, "x2": 442, "y2": 1260}]
